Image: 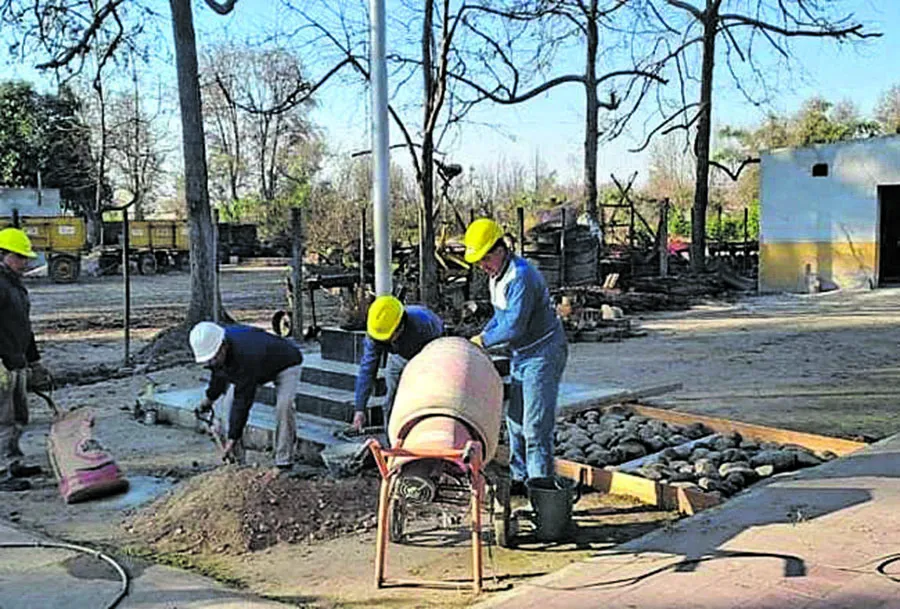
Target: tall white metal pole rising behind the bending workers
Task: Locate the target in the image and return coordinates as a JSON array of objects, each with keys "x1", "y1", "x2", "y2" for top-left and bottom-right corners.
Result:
[{"x1": 369, "y1": 0, "x2": 391, "y2": 296}]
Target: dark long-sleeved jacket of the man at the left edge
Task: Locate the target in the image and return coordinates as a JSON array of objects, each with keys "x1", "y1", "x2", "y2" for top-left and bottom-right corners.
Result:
[{"x1": 0, "y1": 263, "x2": 40, "y2": 370}]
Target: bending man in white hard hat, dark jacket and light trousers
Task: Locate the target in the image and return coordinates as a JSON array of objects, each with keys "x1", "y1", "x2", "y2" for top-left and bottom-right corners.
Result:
[{"x1": 190, "y1": 321, "x2": 303, "y2": 470}]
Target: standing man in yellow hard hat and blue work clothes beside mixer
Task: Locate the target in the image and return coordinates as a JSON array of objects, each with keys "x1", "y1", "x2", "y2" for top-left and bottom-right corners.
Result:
[{"x1": 465, "y1": 218, "x2": 569, "y2": 494}]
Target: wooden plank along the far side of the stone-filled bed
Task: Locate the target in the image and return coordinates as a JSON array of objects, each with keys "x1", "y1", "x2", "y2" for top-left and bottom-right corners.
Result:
[{"x1": 630, "y1": 404, "x2": 866, "y2": 456}]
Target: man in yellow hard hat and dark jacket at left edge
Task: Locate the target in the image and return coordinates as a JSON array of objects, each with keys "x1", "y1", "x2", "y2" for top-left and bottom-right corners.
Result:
[{"x1": 0, "y1": 228, "x2": 47, "y2": 491}]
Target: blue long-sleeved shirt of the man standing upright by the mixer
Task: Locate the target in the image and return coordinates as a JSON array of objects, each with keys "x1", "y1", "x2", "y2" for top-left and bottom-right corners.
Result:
[{"x1": 481, "y1": 254, "x2": 560, "y2": 353}]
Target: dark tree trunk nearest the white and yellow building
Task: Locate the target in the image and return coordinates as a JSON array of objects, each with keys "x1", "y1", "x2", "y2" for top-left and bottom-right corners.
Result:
[{"x1": 691, "y1": 0, "x2": 720, "y2": 272}]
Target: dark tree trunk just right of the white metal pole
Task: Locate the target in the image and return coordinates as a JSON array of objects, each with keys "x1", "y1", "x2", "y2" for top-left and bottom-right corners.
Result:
[{"x1": 419, "y1": 0, "x2": 438, "y2": 307}]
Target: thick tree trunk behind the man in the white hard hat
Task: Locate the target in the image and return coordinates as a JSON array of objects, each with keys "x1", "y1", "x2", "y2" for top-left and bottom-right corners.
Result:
[{"x1": 169, "y1": 0, "x2": 215, "y2": 324}]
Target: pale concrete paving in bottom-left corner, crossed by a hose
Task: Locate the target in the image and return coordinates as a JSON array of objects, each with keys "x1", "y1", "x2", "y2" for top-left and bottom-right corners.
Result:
[{"x1": 0, "y1": 522, "x2": 288, "y2": 609}]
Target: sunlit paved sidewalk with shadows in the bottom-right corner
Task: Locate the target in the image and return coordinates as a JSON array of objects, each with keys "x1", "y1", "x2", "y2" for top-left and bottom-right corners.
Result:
[{"x1": 477, "y1": 436, "x2": 900, "y2": 609}]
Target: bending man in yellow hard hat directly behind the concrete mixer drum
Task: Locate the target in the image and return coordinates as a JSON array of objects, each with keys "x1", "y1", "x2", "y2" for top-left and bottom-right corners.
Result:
[{"x1": 353, "y1": 296, "x2": 444, "y2": 431}]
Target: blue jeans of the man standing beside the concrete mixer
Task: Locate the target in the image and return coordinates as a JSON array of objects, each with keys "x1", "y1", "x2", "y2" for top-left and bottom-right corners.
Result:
[{"x1": 506, "y1": 326, "x2": 569, "y2": 481}]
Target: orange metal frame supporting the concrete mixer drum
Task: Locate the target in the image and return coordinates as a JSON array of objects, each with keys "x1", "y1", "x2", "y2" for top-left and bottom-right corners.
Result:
[{"x1": 366, "y1": 436, "x2": 484, "y2": 594}]
